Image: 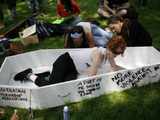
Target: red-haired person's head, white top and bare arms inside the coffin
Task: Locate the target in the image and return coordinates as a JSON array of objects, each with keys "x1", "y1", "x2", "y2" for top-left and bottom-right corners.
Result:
[{"x1": 87, "y1": 35, "x2": 127, "y2": 76}]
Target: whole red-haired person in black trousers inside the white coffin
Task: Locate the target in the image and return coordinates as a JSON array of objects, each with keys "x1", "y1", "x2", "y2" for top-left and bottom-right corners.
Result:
[{"x1": 14, "y1": 36, "x2": 126, "y2": 86}]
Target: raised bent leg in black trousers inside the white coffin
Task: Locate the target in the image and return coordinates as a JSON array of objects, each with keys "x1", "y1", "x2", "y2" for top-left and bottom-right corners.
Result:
[{"x1": 49, "y1": 52, "x2": 78, "y2": 84}]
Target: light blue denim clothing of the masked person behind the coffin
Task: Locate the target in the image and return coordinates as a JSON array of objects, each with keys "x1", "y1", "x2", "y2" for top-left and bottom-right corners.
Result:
[{"x1": 91, "y1": 24, "x2": 113, "y2": 47}]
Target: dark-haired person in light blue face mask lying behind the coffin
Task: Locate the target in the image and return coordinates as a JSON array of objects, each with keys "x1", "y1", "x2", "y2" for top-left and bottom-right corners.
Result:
[{"x1": 64, "y1": 22, "x2": 113, "y2": 48}]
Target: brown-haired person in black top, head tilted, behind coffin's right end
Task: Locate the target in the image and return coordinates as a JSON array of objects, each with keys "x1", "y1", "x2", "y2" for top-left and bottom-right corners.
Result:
[{"x1": 109, "y1": 17, "x2": 152, "y2": 46}]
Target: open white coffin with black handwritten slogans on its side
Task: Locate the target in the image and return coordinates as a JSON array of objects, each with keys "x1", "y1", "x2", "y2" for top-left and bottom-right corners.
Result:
[{"x1": 0, "y1": 47, "x2": 160, "y2": 109}]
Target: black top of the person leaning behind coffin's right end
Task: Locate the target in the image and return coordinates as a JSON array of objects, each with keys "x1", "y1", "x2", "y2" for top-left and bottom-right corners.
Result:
[{"x1": 120, "y1": 19, "x2": 152, "y2": 46}]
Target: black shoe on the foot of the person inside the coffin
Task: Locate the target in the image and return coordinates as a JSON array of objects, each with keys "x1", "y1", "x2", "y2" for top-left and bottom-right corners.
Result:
[{"x1": 14, "y1": 68, "x2": 32, "y2": 82}]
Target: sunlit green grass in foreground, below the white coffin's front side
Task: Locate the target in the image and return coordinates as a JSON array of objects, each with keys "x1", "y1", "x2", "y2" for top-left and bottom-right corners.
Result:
[{"x1": 1, "y1": 83, "x2": 160, "y2": 120}]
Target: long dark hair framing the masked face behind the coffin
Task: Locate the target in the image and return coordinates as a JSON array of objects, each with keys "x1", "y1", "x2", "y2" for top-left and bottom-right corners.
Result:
[{"x1": 66, "y1": 26, "x2": 89, "y2": 48}]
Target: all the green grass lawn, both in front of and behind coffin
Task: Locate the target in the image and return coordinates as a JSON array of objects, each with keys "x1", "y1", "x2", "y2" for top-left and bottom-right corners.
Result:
[{"x1": 0, "y1": 0, "x2": 160, "y2": 120}]
